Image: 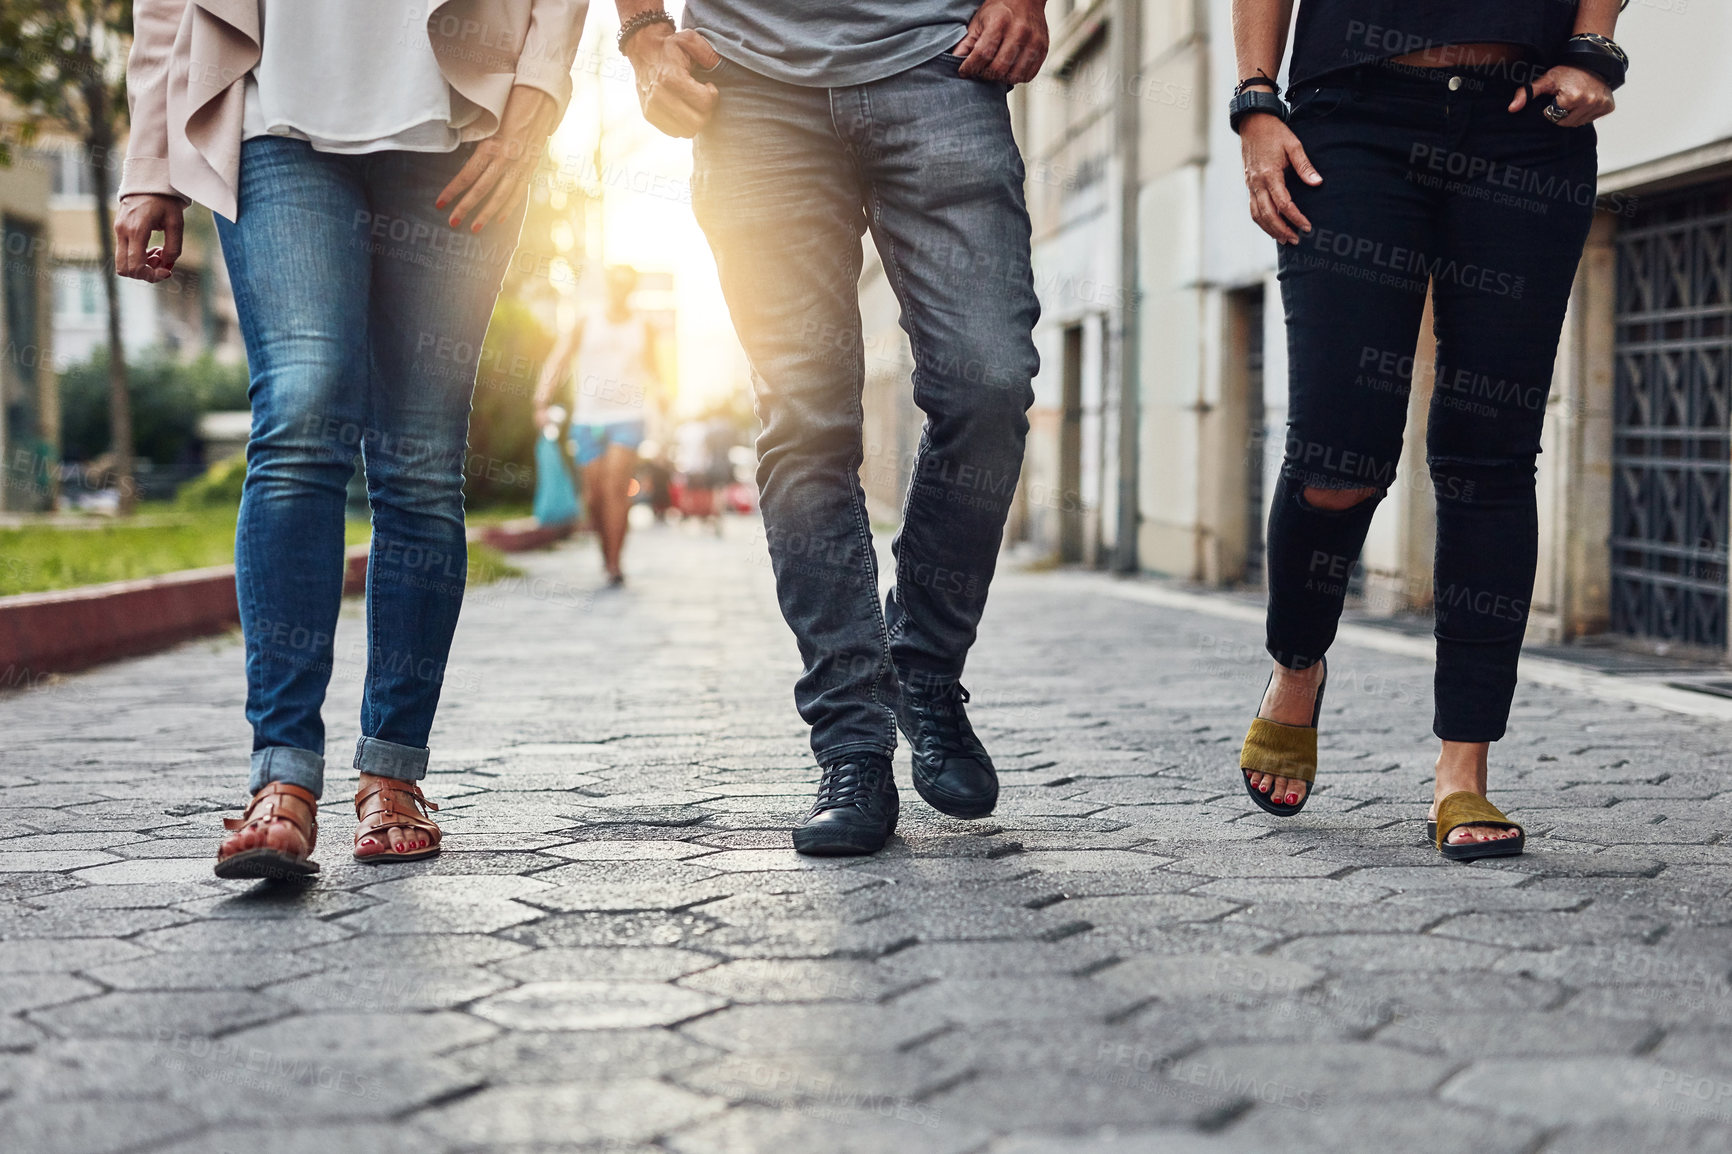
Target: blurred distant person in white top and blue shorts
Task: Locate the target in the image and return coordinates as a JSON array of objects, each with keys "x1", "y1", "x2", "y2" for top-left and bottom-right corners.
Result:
[{"x1": 535, "y1": 265, "x2": 662, "y2": 586}]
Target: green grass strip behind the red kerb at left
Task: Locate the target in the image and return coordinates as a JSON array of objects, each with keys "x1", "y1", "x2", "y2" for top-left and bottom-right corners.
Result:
[{"x1": 0, "y1": 504, "x2": 523, "y2": 596}]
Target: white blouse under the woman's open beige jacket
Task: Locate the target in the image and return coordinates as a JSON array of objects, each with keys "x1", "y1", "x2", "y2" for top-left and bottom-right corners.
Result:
[{"x1": 241, "y1": 0, "x2": 476, "y2": 152}]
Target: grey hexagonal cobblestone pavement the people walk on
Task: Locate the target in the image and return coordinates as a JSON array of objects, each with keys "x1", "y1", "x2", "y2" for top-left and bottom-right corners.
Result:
[{"x1": 0, "y1": 525, "x2": 1732, "y2": 1154}]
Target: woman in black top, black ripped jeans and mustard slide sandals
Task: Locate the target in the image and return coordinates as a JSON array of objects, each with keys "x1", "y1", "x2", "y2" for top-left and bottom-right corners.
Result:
[{"x1": 1230, "y1": 0, "x2": 1628, "y2": 859}]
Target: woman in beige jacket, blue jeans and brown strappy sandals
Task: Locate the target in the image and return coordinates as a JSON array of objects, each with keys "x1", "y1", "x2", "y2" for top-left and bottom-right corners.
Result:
[{"x1": 114, "y1": 0, "x2": 585, "y2": 877}]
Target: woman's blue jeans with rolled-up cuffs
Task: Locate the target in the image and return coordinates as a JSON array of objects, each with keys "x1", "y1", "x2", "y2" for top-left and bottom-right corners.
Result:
[{"x1": 217, "y1": 137, "x2": 521, "y2": 795}]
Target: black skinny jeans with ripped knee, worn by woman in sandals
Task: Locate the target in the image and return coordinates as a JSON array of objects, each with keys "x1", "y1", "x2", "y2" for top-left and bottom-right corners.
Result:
[{"x1": 1266, "y1": 66, "x2": 1597, "y2": 742}]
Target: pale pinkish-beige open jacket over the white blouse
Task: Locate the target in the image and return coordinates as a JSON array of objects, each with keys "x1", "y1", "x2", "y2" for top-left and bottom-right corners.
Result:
[{"x1": 120, "y1": 0, "x2": 589, "y2": 220}]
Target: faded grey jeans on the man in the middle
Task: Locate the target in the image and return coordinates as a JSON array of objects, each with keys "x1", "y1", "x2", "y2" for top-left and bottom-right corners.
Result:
[{"x1": 691, "y1": 55, "x2": 1039, "y2": 764}]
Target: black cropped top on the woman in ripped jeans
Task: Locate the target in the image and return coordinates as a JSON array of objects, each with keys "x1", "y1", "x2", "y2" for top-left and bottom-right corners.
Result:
[{"x1": 1287, "y1": 0, "x2": 1576, "y2": 88}]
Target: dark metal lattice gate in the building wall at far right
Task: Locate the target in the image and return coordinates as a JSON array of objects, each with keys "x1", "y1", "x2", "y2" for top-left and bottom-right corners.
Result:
[{"x1": 1611, "y1": 185, "x2": 1732, "y2": 648}]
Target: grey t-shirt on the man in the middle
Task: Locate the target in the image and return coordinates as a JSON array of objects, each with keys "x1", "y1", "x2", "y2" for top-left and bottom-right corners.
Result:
[{"x1": 681, "y1": 0, "x2": 980, "y2": 88}]
